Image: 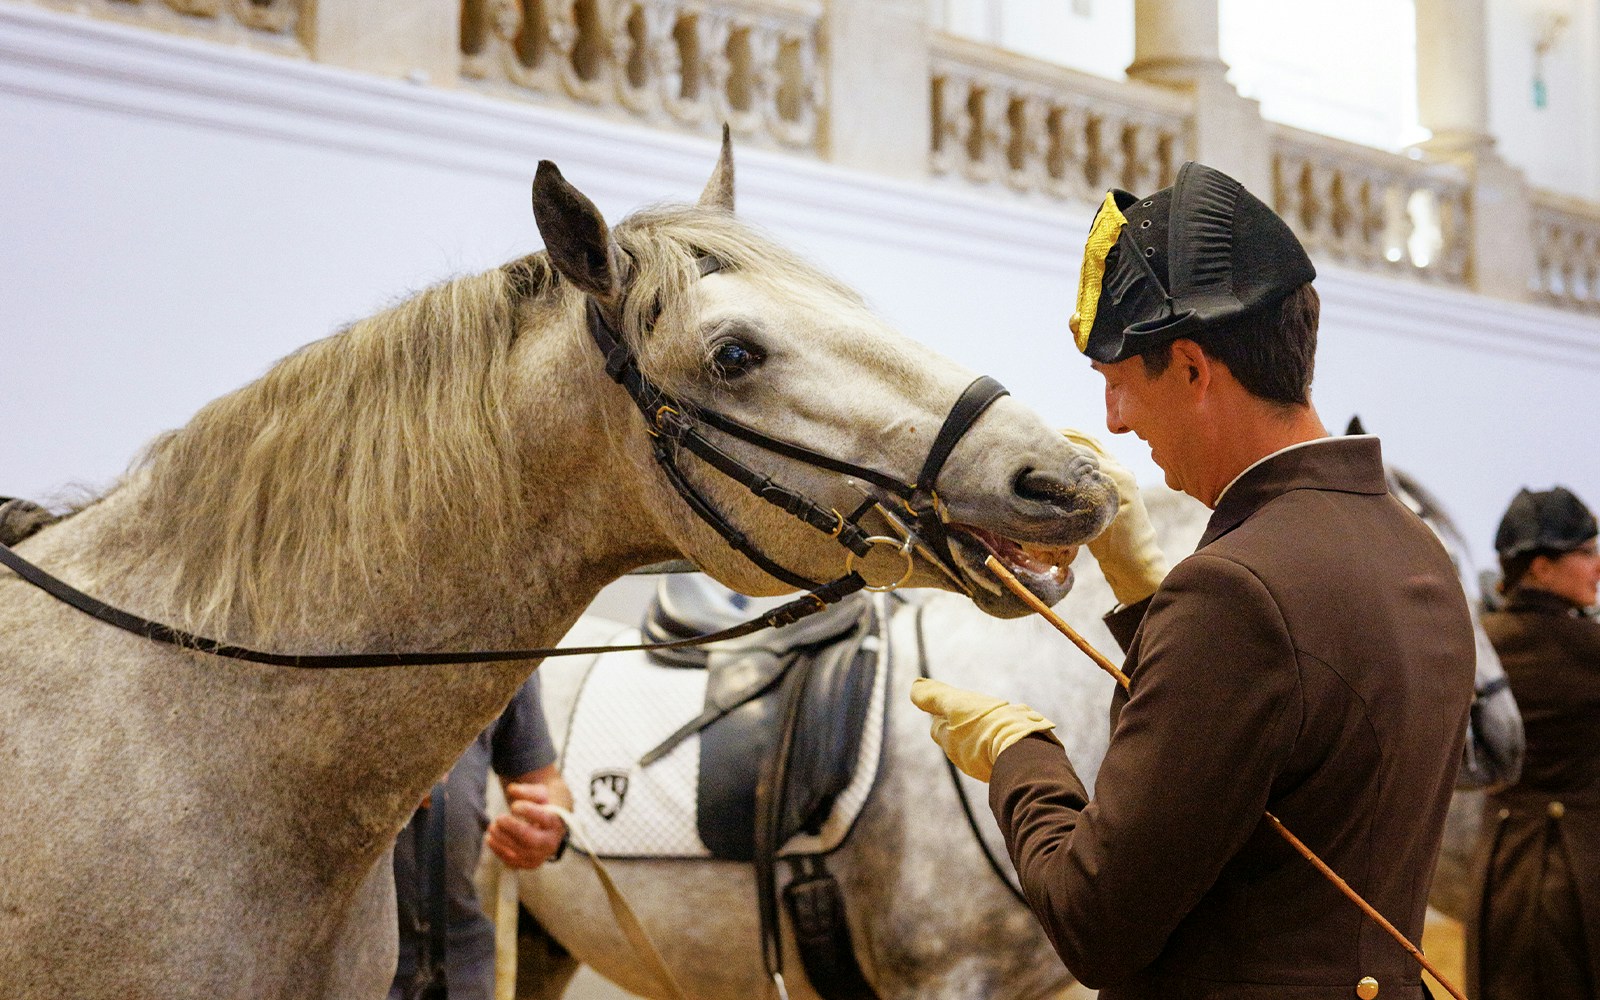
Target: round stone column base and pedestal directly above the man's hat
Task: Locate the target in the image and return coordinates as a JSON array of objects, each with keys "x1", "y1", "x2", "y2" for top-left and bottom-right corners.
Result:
[{"x1": 1128, "y1": 0, "x2": 1272, "y2": 205}]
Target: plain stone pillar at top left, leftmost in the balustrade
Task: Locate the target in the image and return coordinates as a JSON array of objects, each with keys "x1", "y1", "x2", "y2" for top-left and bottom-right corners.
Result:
[{"x1": 301, "y1": 0, "x2": 461, "y2": 86}]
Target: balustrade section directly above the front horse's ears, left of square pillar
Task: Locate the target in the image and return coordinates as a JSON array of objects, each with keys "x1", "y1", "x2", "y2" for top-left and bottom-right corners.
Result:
[{"x1": 461, "y1": 0, "x2": 822, "y2": 150}]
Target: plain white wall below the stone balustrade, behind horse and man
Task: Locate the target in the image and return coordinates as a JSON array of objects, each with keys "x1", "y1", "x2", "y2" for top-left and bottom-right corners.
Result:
[{"x1": 0, "y1": 6, "x2": 1600, "y2": 585}]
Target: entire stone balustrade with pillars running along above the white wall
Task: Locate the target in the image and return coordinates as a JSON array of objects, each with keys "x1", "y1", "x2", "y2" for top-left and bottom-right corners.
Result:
[{"x1": 9, "y1": 0, "x2": 1600, "y2": 320}]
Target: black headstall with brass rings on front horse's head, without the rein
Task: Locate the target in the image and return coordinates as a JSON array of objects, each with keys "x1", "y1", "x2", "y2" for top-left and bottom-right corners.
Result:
[{"x1": 587, "y1": 254, "x2": 1006, "y2": 603}]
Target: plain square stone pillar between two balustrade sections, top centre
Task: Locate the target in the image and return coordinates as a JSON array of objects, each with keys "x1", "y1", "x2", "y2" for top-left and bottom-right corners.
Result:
[{"x1": 822, "y1": 0, "x2": 933, "y2": 179}]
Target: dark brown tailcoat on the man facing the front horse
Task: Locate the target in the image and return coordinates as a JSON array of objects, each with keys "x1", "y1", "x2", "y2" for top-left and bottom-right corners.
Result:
[{"x1": 989, "y1": 437, "x2": 1474, "y2": 1000}]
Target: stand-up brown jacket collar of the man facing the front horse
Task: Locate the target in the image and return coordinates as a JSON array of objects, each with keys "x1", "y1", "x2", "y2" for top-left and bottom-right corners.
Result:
[{"x1": 1198, "y1": 435, "x2": 1389, "y2": 549}]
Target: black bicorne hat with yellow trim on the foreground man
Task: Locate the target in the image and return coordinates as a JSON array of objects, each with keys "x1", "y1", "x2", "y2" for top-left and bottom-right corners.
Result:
[{"x1": 1072, "y1": 162, "x2": 1317, "y2": 363}]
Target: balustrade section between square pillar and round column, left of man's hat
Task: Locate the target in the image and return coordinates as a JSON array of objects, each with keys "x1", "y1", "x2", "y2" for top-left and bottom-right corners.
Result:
[{"x1": 930, "y1": 34, "x2": 1190, "y2": 202}]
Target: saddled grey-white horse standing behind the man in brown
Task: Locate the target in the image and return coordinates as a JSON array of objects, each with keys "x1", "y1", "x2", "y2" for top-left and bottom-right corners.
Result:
[{"x1": 520, "y1": 464, "x2": 1520, "y2": 1000}]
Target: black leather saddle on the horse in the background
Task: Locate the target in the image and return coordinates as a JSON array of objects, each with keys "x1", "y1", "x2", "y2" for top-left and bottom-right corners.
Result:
[{"x1": 643, "y1": 578, "x2": 883, "y2": 1000}]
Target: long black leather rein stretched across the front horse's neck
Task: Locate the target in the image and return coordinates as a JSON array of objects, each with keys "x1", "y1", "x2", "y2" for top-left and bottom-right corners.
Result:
[{"x1": 0, "y1": 544, "x2": 866, "y2": 670}]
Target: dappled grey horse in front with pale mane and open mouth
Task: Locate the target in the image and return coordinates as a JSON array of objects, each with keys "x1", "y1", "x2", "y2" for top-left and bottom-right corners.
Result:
[{"x1": 0, "y1": 138, "x2": 1115, "y2": 1000}]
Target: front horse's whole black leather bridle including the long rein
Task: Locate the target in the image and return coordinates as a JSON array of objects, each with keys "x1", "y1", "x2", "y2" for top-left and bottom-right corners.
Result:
[{"x1": 0, "y1": 254, "x2": 1006, "y2": 669}]
